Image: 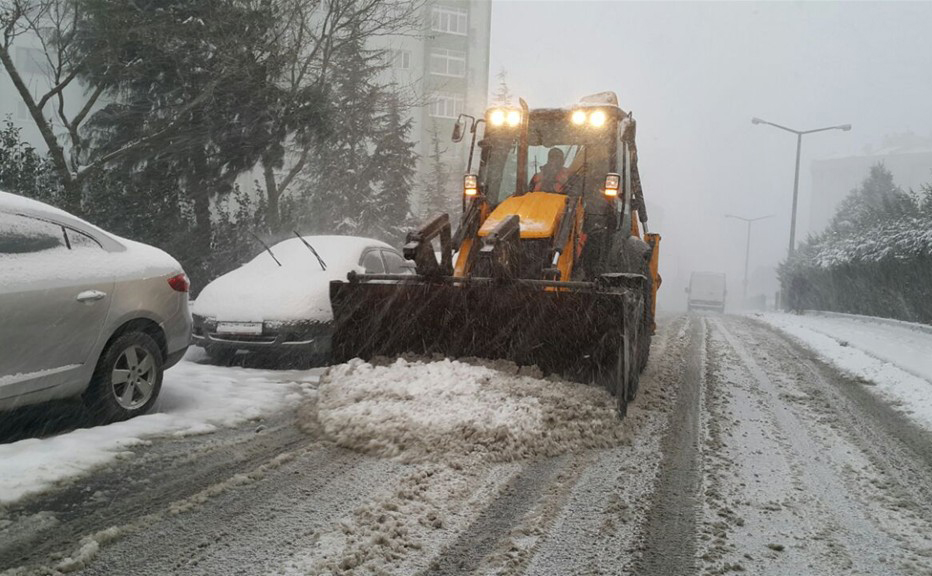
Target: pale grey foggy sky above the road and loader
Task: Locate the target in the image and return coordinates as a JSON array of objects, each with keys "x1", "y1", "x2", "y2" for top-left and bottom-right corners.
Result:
[{"x1": 490, "y1": 0, "x2": 932, "y2": 310}]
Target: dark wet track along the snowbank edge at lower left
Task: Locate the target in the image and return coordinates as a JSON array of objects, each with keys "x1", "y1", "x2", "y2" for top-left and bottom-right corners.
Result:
[{"x1": 0, "y1": 412, "x2": 312, "y2": 568}]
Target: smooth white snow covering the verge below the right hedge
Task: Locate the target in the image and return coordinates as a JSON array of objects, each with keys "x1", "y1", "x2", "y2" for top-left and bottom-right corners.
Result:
[{"x1": 759, "y1": 313, "x2": 932, "y2": 430}]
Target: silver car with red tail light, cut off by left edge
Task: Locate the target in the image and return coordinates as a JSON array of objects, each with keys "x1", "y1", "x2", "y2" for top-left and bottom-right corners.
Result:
[{"x1": 0, "y1": 192, "x2": 191, "y2": 422}]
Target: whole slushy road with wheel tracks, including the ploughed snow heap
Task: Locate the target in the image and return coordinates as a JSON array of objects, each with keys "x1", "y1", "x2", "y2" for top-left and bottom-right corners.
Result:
[{"x1": 0, "y1": 315, "x2": 932, "y2": 575}]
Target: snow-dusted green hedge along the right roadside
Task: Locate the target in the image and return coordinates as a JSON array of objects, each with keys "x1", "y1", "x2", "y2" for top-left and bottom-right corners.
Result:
[{"x1": 779, "y1": 165, "x2": 932, "y2": 323}]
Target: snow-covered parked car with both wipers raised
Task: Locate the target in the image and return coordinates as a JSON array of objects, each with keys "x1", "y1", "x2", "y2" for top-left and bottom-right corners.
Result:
[{"x1": 193, "y1": 236, "x2": 413, "y2": 362}]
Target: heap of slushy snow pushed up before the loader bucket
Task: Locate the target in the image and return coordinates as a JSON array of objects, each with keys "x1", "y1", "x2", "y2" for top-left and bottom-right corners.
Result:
[{"x1": 317, "y1": 359, "x2": 621, "y2": 461}]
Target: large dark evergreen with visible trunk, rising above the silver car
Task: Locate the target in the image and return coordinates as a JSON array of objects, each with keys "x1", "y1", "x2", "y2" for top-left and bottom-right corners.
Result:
[{"x1": 75, "y1": 0, "x2": 283, "y2": 257}]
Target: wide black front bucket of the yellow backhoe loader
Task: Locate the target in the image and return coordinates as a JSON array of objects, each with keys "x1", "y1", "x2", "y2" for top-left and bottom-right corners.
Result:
[{"x1": 330, "y1": 274, "x2": 645, "y2": 392}]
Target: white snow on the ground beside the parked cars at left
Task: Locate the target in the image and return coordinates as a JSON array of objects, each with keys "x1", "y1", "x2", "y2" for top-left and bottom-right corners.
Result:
[{"x1": 0, "y1": 350, "x2": 321, "y2": 504}]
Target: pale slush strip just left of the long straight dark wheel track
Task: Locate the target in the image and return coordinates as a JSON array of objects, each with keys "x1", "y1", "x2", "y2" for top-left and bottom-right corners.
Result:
[{"x1": 524, "y1": 315, "x2": 689, "y2": 576}]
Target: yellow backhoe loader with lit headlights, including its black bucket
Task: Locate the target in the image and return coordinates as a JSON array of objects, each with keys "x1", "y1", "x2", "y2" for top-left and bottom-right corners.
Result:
[{"x1": 330, "y1": 92, "x2": 660, "y2": 415}]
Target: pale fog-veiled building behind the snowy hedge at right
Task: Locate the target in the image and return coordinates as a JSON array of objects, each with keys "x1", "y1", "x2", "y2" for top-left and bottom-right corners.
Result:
[{"x1": 809, "y1": 133, "x2": 932, "y2": 233}]
